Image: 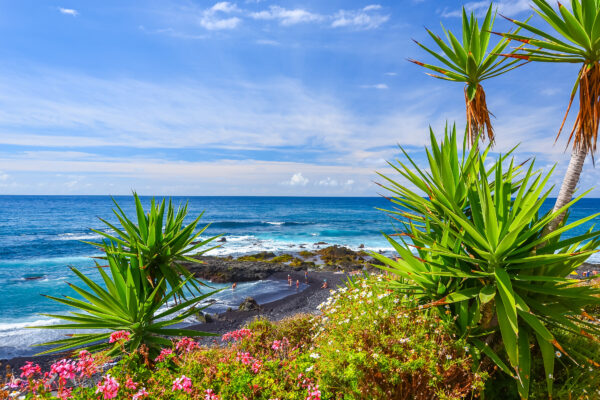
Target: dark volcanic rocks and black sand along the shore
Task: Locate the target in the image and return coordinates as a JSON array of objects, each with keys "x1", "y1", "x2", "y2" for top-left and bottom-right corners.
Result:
[{"x1": 0, "y1": 246, "x2": 600, "y2": 370}]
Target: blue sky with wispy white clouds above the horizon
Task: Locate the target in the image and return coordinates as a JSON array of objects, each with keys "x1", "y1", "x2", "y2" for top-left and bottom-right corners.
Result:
[{"x1": 0, "y1": 0, "x2": 600, "y2": 197}]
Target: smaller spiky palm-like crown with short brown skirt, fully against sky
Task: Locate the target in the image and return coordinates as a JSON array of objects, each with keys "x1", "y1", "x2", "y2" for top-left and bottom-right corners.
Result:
[{"x1": 409, "y1": 5, "x2": 522, "y2": 145}]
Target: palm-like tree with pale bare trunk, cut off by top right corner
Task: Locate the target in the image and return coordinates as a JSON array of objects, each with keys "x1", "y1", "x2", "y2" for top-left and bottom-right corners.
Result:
[{"x1": 502, "y1": 0, "x2": 600, "y2": 230}]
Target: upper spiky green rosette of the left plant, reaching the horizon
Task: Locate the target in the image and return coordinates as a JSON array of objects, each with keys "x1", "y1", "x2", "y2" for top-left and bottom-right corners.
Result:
[{"x1": 88, "y1": 193, "x2": 219, "y2": 301}]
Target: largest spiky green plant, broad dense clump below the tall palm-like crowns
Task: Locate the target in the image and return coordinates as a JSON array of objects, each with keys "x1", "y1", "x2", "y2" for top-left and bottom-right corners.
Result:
[{"x1": 372, "y1": 127, "x2": 600, "y2": 398}]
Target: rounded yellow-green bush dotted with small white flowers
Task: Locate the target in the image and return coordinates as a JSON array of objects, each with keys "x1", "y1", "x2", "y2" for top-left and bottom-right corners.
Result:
[{"x1": 312, "y1": 276, "x2": 485, "y2": 400}]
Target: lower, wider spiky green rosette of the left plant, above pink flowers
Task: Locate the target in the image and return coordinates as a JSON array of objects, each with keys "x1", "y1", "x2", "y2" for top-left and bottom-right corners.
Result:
[{"x1": 34, "y1": 248, "x2": 218, "y2": 356}]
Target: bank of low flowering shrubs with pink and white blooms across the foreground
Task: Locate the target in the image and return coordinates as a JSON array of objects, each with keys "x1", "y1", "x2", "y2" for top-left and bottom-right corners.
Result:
[{"x1": 8, "y1": 277, "x2": 485, "y2": 400}]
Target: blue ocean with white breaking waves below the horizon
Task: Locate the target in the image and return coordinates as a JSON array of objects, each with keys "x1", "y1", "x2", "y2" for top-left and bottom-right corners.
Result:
[{"x1": 0, "y1": 196, "x2": 600, "y2": 359}]
